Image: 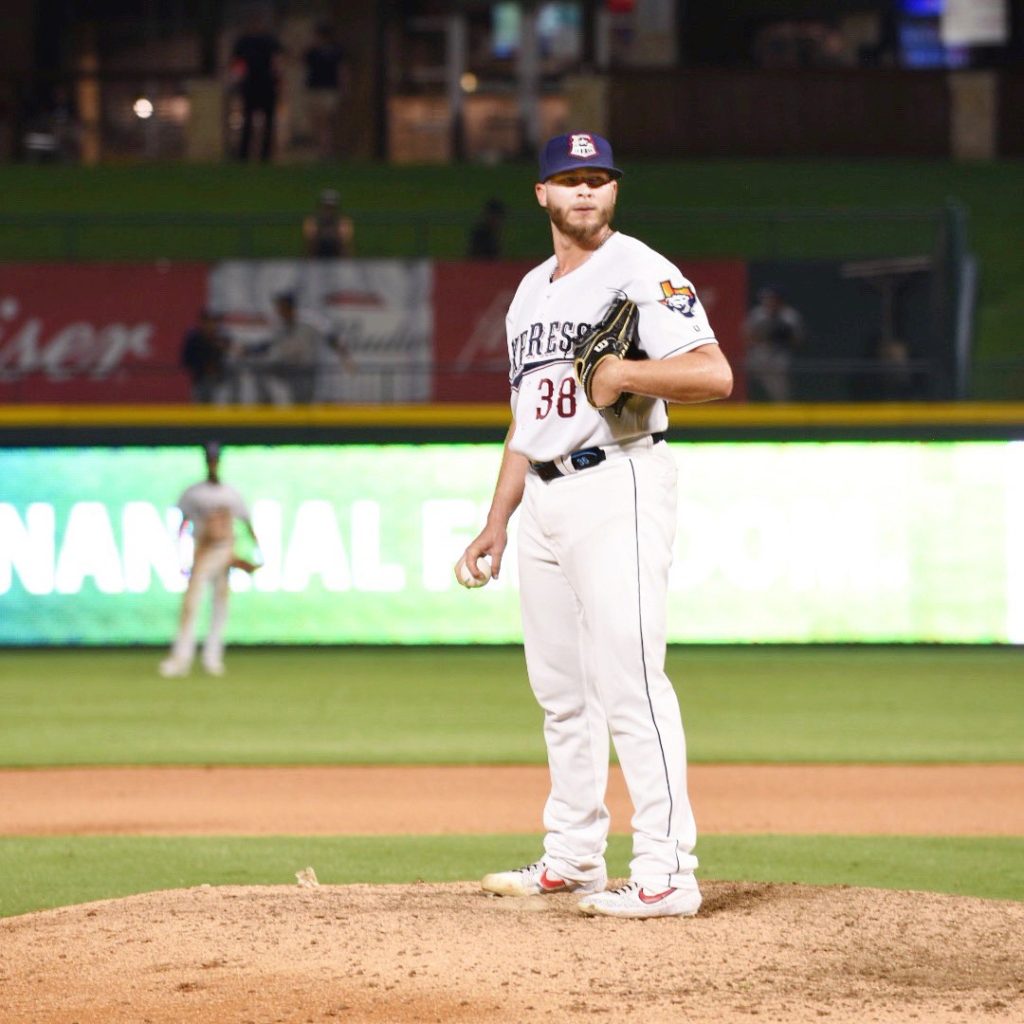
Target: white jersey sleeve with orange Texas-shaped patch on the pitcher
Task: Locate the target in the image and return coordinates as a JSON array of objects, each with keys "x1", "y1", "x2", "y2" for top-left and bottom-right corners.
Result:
[{"x1": 628, "y1": 252, "x2": 718, "y2": 359}]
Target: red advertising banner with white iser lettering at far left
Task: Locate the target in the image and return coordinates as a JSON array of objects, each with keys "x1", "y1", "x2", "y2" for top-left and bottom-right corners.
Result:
[{"x1": 0, "y1": 263, "x2": 209, "y2": 403}]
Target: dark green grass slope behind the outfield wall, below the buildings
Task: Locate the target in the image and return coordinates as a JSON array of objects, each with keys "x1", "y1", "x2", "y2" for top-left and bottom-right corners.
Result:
[{"x1": 0, "y1": 160, "x2": 1024, "y2": 387}]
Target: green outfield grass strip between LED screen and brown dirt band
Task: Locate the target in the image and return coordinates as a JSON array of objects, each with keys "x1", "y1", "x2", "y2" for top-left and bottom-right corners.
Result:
[{"x1": 0, "y1": 647, "x2": 1024, "y2": 767}]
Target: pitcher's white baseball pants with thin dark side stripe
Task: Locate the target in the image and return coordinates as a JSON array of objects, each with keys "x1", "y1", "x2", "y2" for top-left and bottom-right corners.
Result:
[{"x1": 518, "y1": 438, "x2": 697, "y2": 889}]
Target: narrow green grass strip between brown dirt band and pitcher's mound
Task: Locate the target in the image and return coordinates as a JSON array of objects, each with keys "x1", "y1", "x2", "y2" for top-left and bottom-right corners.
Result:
[{"x1": 0, "y1": 836, "x2": 1024, "y2": 918}]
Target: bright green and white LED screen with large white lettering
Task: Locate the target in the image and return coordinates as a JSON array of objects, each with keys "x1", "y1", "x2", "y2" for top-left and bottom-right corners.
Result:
[{"x1": 0, "y1": 441, "x2": 1024, "y2": 644}]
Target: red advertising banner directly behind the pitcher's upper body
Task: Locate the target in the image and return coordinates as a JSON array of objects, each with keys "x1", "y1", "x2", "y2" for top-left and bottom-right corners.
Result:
[{"x1": 433, "y1": 260, "x2": 748, "y2": 401}]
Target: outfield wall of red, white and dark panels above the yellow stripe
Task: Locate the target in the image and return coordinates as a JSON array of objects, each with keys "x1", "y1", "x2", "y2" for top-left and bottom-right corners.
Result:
[{"x1": 0, "y1": 249, "x2": 969, "y2": 404}]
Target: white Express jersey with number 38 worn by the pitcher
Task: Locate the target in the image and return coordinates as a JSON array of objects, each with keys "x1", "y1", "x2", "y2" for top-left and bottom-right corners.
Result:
[{"x1": 506, "y1": 231, "x2": 717, "y2": 462}]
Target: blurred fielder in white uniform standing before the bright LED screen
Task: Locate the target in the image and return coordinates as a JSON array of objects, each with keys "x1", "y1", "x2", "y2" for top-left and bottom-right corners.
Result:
[{"x1": 160, "y1": 441, "x2": 259, "y2": 677}]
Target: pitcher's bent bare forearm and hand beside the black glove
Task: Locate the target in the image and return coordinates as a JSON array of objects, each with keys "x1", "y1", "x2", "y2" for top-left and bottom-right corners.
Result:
[{"x1": 592, "y1": 342, "x2": 732, "y2": 406}]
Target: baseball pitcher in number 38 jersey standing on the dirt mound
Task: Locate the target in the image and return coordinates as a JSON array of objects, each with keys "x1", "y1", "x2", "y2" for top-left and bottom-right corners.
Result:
[{"x1": 456, "y1": 132, "x2": 732, "y2": 918}]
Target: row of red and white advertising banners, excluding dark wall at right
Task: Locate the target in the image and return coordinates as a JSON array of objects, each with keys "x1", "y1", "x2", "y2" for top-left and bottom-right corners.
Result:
[{"x1": 0, "y1": 259, "x2": 745, "y2": 404}]
